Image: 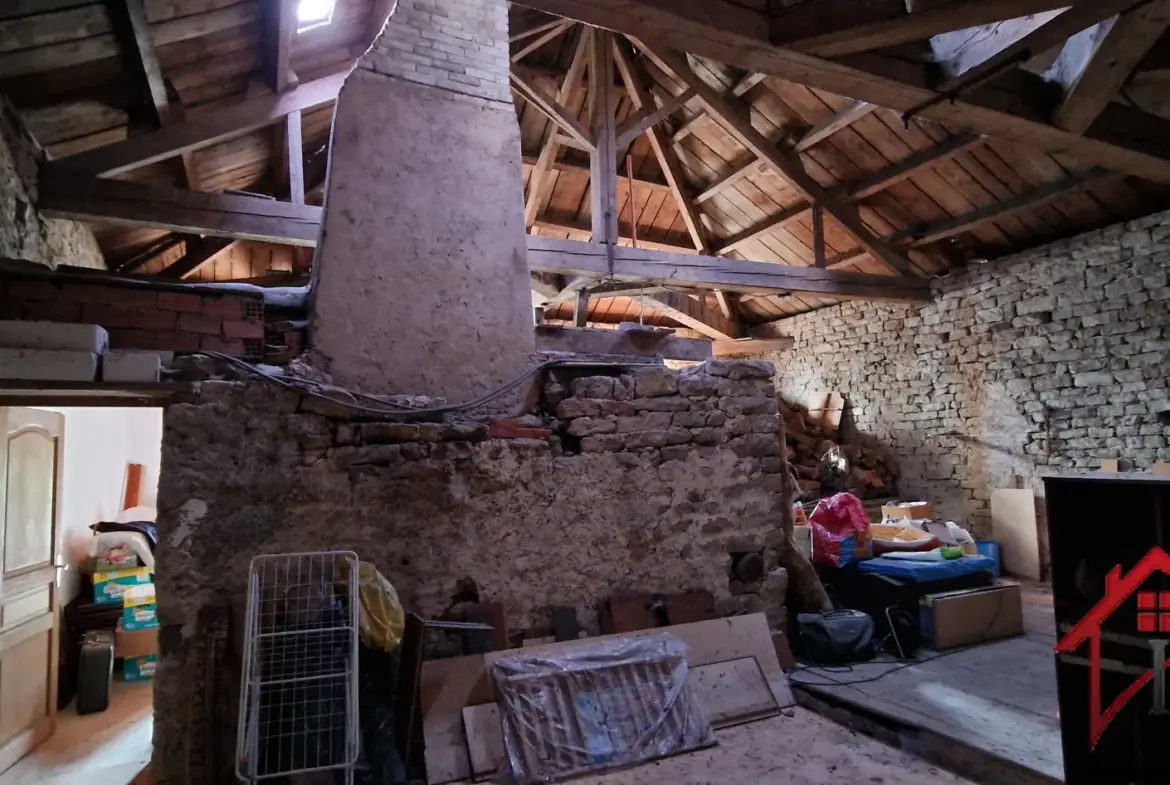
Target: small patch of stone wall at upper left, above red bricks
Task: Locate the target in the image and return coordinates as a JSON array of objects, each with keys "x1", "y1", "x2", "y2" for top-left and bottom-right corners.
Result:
[{"x1": 0, "y1": 104, "x2": 105, "y2": 269}]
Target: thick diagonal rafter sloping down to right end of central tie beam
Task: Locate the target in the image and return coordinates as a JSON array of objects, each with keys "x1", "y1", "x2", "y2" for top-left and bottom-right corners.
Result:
[{"x1": 642, "y1": 44, "x2": 913, "y2": 275}]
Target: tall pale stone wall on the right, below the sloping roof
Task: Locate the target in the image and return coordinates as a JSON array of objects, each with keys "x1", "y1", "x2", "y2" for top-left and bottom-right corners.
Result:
[{"x1": 771, "y1": 213, "x2": 1170, "y2": 536}]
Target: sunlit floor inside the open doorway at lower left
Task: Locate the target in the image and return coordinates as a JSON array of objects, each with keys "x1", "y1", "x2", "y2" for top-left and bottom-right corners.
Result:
[{"x1": 0, "y1": 680, "x2": 153, "y2": 785}]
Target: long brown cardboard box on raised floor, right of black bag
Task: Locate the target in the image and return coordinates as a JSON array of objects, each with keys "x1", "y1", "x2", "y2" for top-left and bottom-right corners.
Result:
[{"x1": 918, "y1": 584, "x2": 1024, "y2": 649}]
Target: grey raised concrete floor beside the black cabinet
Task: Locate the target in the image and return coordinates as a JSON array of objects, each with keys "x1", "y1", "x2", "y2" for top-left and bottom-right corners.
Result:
[{"x1": 791, "y1": 586, "x2": 1065, "y2": 785}]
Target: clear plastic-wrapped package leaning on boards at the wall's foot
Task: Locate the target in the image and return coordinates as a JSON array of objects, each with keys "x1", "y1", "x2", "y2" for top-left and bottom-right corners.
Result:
[{"x1": 493, "y1": 634, "x2": 715, "y2": 785}]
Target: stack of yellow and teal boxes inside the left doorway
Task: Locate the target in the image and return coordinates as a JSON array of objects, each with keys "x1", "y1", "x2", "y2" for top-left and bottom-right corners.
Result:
[{"x1": 94, "y1": 567, "x2": 158, "y2": 681}]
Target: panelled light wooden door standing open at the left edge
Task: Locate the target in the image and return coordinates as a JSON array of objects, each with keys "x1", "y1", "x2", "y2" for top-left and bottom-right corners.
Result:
[{"x1": 0, "y1": 407, "x2": 64, "y2": 771}]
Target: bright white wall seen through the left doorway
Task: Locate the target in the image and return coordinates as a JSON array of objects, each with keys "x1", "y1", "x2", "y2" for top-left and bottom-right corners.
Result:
[{"x1": 41, "y1": 406, "x2": 163, "y2": 605}]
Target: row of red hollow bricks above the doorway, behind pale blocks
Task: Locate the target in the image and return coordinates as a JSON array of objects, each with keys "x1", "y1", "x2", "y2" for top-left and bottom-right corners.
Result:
[{"x1": 0, "y1": 275, "x2": 264, "y2": 357}]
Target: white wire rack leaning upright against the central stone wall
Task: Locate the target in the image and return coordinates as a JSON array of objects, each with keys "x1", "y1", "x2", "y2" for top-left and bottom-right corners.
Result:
[{"x1": 235, "y1": 551, "x2": 359, "y2": 785}]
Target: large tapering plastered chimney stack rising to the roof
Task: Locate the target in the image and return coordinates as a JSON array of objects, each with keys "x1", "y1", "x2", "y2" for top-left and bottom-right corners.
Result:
[{"x1": 311, "y1": 0, "x2": 534, "y2": 402}]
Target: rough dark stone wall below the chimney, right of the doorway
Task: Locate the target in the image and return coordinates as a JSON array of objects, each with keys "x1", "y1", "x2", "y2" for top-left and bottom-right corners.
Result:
[{"x1": 151, "y1": 360, "x2": 783, "y2": 784}]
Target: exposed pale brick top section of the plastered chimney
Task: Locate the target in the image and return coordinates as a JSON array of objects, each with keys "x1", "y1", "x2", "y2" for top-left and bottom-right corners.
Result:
[{"x1": 358, "y1": 0, "x2": 511, "y2": 105}]
